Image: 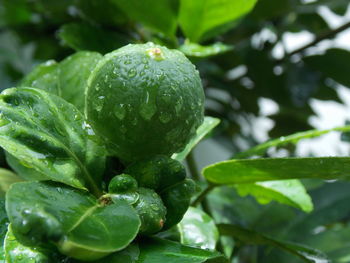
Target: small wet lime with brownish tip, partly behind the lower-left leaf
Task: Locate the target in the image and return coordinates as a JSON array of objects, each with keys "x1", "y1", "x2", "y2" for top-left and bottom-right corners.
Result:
[{"x1": 133, "y1": 187, "x2": 167, "y2": 235}]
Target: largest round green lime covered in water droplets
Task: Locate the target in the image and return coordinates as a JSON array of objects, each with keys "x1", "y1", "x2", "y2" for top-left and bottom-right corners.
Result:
[{"x1": 85, "y1": 43, "x2": 204, "y2": 163}]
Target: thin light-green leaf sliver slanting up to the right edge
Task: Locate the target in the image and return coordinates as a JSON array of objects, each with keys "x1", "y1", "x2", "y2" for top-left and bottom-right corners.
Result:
[{"x1": 233, "y1": 125, "x2": 350, "y2": 158}]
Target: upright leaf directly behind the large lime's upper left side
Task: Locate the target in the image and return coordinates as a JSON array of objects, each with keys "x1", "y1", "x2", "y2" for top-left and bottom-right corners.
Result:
[{"x1": 58, "y1": 51, "x2": 102, "y2": 112}]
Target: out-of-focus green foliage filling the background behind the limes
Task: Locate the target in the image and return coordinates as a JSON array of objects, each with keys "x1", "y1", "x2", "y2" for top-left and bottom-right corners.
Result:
[{"x1": 0, "y1": 0, "x2": 350, "y2": 263}]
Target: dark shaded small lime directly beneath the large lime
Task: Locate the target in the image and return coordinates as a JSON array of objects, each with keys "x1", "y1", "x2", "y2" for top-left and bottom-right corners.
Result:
[{"x1": 124, "y1": 155, "x2": 186, "y2": 192}]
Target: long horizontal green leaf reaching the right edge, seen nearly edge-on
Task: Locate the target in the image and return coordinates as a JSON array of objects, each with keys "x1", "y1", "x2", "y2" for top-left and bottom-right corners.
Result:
[{"x1": 203, "y1": 157, "x2": 350, "y2": 184}]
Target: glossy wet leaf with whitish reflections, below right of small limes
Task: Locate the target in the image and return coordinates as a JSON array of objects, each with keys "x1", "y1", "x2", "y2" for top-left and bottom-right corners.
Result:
[{"x1": 177, "y1": 207, "x2": 219, "y2": 250}]
